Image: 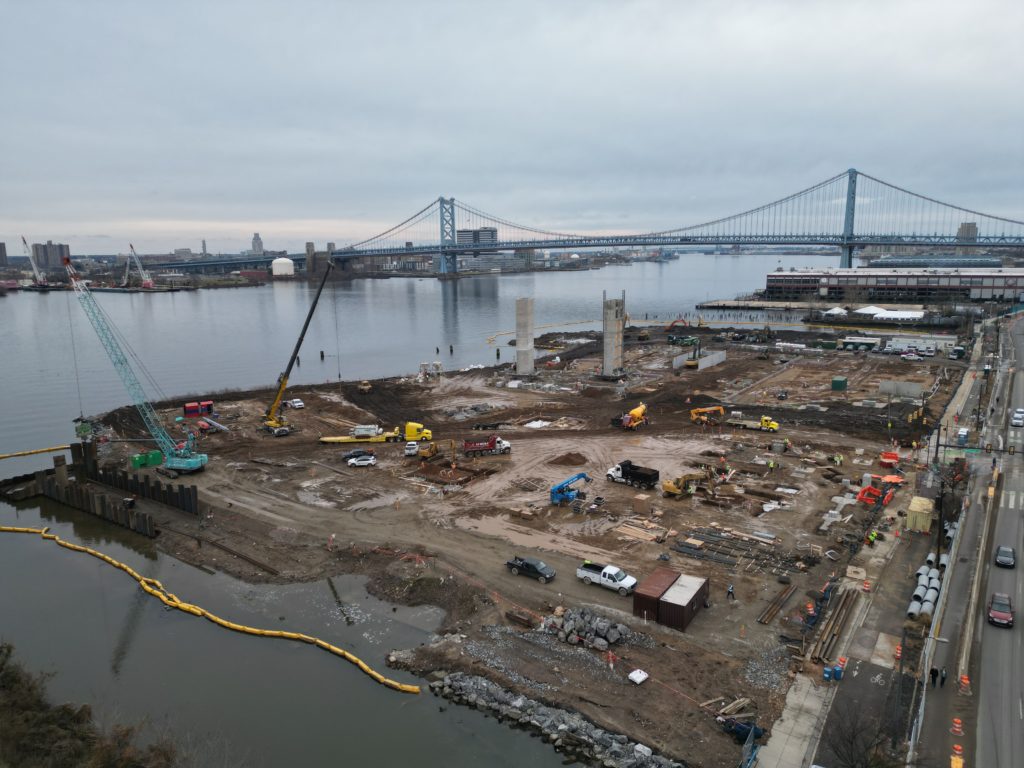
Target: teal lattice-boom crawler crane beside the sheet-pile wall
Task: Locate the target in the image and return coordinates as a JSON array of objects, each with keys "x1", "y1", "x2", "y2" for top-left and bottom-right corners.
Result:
[{"x1": 63, "y1": 257, "x2": 207, "y2": 472}]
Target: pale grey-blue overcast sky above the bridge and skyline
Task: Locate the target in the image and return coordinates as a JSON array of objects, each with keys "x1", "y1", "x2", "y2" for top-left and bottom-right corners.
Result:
[{"x1": 0, "y1": 0, "x2": 1024, "y2": 254}]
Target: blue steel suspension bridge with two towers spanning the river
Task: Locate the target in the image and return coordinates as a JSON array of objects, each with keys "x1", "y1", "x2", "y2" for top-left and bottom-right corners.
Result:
[{"x1": 331, "y1": 169, "x2": 1024, "y2": 274}]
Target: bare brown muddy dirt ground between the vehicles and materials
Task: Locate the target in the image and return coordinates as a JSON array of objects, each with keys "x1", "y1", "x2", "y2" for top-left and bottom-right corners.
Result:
[{"x1": 92, "y1": 329, "x2": 964, "y2": 768}]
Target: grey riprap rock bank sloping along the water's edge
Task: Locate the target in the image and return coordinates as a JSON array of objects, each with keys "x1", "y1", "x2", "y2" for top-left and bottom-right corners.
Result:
[{"x1": 430, "y1": 672, "x2": 686, "y2": 768}]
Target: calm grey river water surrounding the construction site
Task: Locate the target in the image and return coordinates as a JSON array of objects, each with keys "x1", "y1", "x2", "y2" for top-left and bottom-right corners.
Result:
[{"x1": 0, "y1": 255, "x2": 835, "y2": 766}]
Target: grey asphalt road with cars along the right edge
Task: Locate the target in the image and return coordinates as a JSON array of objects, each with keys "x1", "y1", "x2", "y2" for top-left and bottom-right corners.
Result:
[{"x1": 974, "y1": 315, "x2": 1024, "y2": 768}]
